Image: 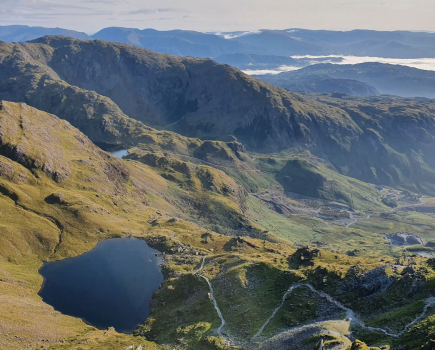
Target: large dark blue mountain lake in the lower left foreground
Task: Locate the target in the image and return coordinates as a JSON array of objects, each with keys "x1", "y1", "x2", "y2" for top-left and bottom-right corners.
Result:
[{"x1": 39, "y1": 239, "x2": 163, "y2": 333}]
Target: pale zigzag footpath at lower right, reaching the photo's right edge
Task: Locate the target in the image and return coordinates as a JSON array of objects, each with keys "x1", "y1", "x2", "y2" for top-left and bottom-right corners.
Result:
[{"x1": 252, "y1": 283, "x2": 435, "y2": 340}]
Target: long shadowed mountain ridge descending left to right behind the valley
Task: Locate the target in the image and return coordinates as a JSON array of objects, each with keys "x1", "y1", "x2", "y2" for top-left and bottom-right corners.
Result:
[{"x1": 0, "y1": 37, "x2": 434, "y2": 191}]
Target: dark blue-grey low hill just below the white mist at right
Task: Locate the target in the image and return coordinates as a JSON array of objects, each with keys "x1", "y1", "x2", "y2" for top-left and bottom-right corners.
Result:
[{"x1": 256, "y1": 63, "x2": 435, "y2": 98}]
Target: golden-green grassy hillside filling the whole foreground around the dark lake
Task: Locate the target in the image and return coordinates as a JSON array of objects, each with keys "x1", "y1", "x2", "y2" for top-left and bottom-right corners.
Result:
[{"x1": 0, "y1": 102, "x2": 435, "y2": 350}]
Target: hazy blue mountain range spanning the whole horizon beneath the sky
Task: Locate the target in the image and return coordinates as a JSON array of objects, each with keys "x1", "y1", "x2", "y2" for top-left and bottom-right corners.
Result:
[{"x1": 0, "y1": 26, "x2": 435, "y2": 58}]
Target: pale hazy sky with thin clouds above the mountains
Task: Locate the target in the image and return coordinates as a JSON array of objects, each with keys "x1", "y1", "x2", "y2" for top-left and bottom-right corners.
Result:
[{"x1": 0, "y1": 0, "x2": 435, "y2": 33}]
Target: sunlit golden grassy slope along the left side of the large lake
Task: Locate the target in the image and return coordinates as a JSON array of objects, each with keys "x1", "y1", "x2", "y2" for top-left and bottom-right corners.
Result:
[{"x1": 0, "y1": 102, "x2": 262, "y2": 349}]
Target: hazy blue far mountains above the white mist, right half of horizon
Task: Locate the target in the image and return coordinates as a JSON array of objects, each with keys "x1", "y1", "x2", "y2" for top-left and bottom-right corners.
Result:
[{"x1": 221, "y1": 28, "x2": 435, "y2": 58}]
